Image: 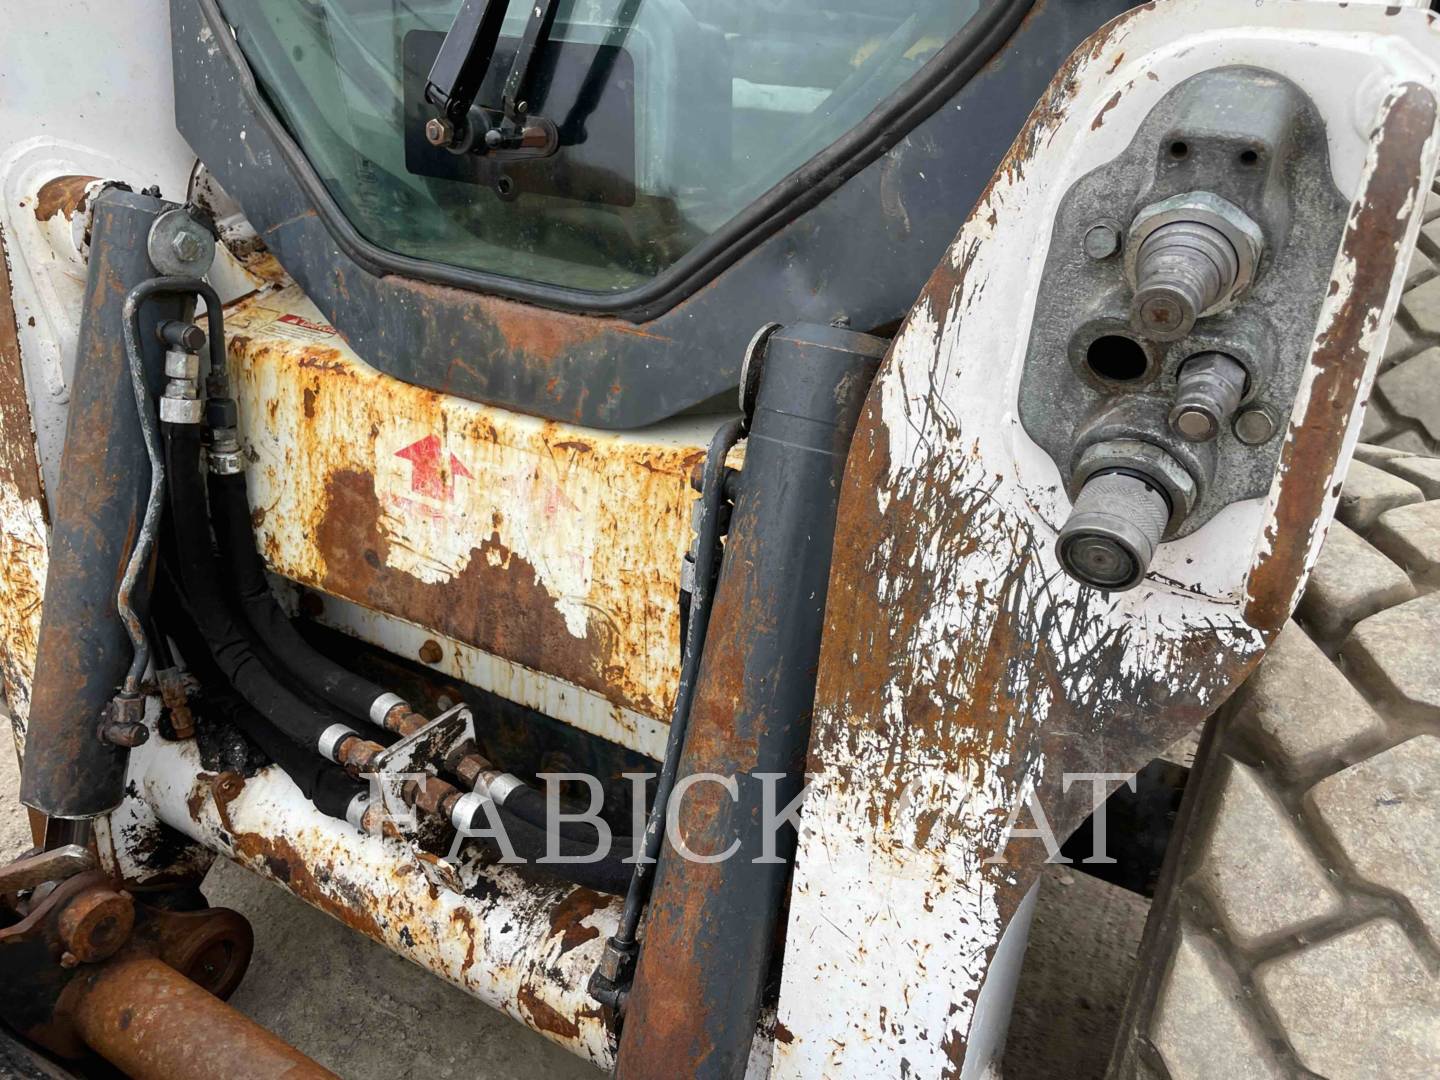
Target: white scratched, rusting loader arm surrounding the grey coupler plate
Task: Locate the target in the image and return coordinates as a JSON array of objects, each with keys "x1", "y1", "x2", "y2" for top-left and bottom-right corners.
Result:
[{"x1": 772, "y1": 0, "x2": 1440, "y2": 1077}]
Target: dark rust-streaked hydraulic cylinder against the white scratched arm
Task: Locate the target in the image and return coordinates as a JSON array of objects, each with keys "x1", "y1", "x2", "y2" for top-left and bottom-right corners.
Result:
[{"x1": 616, "y1": 325, "x2": 886, "y2": 1080}]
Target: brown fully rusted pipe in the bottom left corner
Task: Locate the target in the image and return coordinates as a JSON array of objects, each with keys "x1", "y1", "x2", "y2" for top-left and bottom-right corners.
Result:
[{"x1": 65, "y1": 956, "x2": 338, "y2": 1080}]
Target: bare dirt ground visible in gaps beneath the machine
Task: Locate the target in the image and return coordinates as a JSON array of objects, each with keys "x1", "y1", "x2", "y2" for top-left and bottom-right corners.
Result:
[{"x1": 0, "y1": 747, "x2": 1146, "y2": 1080}]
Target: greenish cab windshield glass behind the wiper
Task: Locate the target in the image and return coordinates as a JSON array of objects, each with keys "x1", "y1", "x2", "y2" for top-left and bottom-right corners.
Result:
[{"x1": 222, "y1": 0, "x2": 979, "y2": 292}]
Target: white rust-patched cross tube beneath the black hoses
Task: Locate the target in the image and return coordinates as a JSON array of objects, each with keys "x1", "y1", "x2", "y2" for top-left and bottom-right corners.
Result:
[{"x1": 125, "y1": 739, "x2": 621, "y2": 1068}]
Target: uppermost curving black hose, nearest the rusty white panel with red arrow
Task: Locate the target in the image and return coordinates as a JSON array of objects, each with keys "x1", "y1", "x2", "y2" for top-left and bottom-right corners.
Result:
[{"x1": 210, "y1": 472, "x2": 400, "y2": 723}]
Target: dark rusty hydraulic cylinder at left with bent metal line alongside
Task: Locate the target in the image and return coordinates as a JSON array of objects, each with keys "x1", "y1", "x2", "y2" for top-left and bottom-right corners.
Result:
[{"x1": 20, "y1": 187, "x2": 183, "y2": 818}]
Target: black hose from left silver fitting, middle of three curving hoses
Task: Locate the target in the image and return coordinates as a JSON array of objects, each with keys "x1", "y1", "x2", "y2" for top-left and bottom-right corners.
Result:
[{"x1": 160, "y1": 423, "x2": 350, "y2": 750}]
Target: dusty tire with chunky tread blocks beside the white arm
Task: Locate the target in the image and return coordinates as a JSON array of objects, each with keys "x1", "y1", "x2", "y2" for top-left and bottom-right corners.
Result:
[{"x1": 1110, "y1": 440, "x2": 1440, "y2": 1080}]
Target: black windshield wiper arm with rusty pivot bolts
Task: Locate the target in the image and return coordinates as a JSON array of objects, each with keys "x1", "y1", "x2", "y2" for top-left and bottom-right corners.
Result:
[{"x1": 425, "y1": 0, "x2": 559, "y2": 157}]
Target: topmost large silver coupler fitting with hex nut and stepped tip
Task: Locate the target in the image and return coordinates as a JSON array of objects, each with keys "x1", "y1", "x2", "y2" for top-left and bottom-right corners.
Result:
[{"x1": 1126, "y1": 192, "x2": 1264, "y2": 341}]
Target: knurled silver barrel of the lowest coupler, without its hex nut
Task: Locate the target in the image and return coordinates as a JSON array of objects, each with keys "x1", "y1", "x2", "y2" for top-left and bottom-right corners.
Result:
[{"x1": 1057, "y1": 472, "x2": 1171, "y2": 592}]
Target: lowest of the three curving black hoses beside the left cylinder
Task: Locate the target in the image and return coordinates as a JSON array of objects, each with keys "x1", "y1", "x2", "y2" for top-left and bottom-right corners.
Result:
[{"x1": 156, "y1": 573, "x2": 367, "y2": 819}]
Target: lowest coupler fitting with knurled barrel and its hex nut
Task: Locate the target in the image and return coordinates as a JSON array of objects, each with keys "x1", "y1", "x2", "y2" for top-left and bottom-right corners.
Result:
[{"x1": 1056, "y1": 439, "x2": 1195, "y2": 592}]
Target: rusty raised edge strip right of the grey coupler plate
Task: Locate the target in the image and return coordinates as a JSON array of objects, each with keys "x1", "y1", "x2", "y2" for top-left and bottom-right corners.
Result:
[{"x1": 1246, "y1": 82, "x2": 1436, "y2": 634}]
